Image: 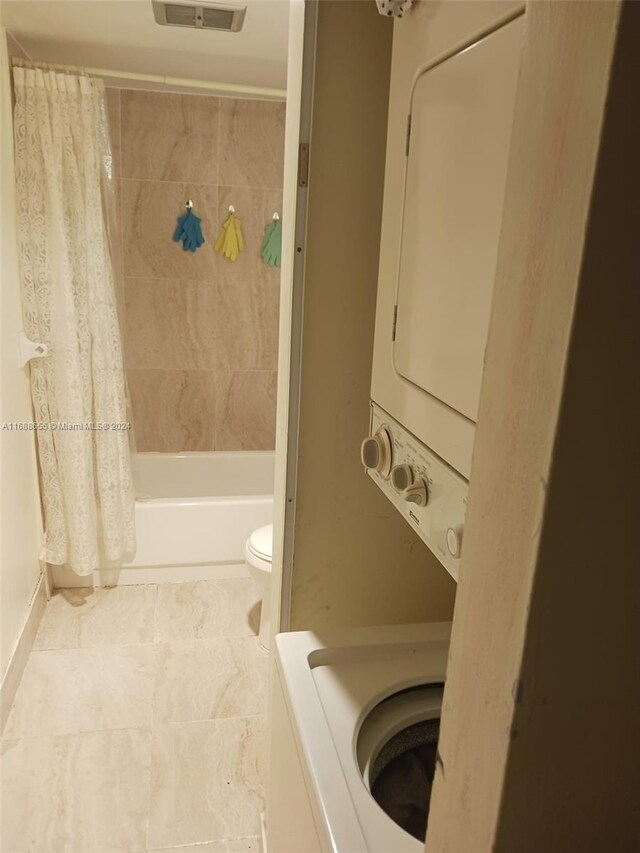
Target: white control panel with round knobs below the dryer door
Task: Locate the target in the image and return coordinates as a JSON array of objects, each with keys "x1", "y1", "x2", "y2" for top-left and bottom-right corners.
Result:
[{"x1": 361, "y1": 403, "x2": 469, "y2": 581}]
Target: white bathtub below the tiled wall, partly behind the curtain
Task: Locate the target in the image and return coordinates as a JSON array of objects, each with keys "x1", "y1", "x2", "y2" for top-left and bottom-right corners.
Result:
[{"x1": 53, "y1": 451, "x2": 274, "y2": 586}]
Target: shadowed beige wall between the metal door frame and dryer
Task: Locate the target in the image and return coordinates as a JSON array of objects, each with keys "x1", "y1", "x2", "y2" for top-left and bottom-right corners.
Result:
[{"x1": 291, "y1": 0, "x2": 455, "y2": 630}]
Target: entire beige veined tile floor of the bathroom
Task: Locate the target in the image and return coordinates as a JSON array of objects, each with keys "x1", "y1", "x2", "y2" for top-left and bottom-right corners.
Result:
[{"x1": 0, "y1": 578, "x2": 267, "y2": 853}]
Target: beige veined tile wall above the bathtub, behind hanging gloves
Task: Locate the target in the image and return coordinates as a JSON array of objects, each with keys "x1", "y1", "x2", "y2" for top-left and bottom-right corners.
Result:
[{"x1": 107, "y1": 89, "x2": 284, "y2": 452}]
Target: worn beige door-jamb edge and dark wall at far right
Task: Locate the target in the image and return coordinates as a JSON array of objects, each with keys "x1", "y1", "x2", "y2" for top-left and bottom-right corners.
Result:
[{"x1": 426, "y1": 2, "x2": 640, "y2": 853}]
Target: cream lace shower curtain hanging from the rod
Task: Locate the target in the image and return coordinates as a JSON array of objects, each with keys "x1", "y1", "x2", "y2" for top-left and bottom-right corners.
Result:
[{"x1": 13, "y1": 67, "x2": 135, "y2": 575}]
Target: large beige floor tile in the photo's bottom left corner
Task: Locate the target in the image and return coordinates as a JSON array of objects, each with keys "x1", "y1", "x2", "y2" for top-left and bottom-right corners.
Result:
[{"x1": 2, "y1": 731, "x2": 151, "y2": 853}]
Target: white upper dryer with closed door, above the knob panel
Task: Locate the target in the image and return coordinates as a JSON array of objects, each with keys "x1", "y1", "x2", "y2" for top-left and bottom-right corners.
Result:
[{"x1": 363, "y1": 2, "x2": 525, "y2": 541}]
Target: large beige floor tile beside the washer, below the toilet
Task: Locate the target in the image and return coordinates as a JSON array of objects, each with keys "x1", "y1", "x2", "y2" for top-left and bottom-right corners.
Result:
[{"x1": 147, "y1": 717, "x2": 265, "y2": 850}]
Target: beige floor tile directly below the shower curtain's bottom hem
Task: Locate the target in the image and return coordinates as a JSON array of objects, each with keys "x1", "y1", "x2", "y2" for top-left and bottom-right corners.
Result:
[{"x1": 34, "y1": 585, "x2": 157, "y2": 651}]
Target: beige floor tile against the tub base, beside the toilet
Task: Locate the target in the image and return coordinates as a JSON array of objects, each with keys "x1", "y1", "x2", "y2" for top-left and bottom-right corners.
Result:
[{"x1": 156, "y1": 578, "x2": 260, "y2": 642}]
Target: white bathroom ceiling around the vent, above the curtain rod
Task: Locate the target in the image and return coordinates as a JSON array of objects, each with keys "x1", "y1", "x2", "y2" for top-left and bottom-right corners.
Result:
[{"x1": 0, "y1": 0, "x2": 289, "y2": 88}]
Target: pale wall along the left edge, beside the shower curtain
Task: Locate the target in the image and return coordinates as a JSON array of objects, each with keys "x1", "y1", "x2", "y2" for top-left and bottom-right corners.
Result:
[{"x1": 0, "y1": 29, "x2": 41, "y2": 680}]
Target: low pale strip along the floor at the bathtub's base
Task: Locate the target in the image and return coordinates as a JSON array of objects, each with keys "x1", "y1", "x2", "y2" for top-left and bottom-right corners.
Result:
[{"x1": 52, "y1": 562, "x2": 249, "y2": 589}]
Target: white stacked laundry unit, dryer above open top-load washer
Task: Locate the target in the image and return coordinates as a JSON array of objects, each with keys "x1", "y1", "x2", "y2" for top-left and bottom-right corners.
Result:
[{"x1": 267, "y1": 0, "x2": 525, "y2": 853}]
